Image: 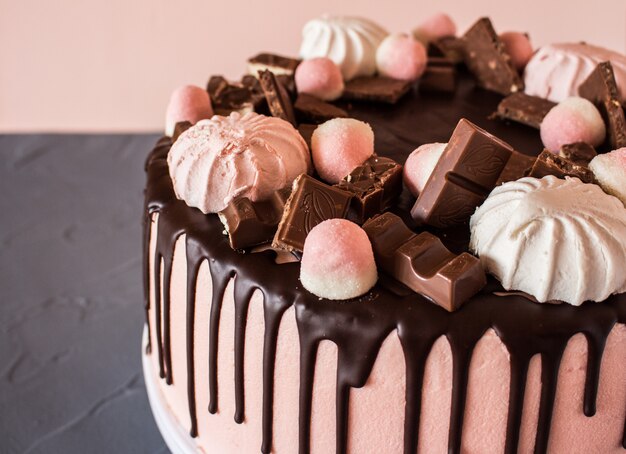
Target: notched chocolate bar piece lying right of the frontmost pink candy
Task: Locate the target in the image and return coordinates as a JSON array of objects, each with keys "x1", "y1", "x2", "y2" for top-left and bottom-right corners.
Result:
[{"x1": 363, "y1": 213, "x2": 487, "y2": 312}]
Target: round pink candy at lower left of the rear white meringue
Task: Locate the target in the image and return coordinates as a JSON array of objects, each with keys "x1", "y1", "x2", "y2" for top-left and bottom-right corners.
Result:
[{"x1": 294, "y1": 57, "x2": 343, "y2": 101}]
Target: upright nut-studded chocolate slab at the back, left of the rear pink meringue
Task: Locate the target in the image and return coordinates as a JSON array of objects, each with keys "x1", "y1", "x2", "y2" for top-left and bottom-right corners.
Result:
[{"x1": 463, "y1": 17, "x2": 524, "y2": 96}]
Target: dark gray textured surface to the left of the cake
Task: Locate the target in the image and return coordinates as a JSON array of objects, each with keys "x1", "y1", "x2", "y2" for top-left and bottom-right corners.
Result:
[{"x1": 0, "y1": 135, "x2": 167, "y2": 454}]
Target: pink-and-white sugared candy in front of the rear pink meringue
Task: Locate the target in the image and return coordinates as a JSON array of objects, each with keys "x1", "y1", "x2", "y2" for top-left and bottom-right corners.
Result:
[{"x1": 540, "y1": 96, "x2": 606, "y2": 154}]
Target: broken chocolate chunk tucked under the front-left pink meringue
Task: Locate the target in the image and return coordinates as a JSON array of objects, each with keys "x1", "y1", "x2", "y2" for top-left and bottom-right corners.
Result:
[{"x1": 218, "y1": 187, "x2": 291, "y2": 249}]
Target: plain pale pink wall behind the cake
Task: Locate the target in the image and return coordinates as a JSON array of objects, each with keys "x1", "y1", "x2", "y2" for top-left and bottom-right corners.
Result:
[{"x1": 0, "y1": 0, "x2": 626, "y2": 132}]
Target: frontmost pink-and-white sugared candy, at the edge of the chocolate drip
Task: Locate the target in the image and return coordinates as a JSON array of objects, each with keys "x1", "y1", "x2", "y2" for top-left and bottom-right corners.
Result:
[{"x1": 300, "y1": 219, "x2": 378, "y2": 300}]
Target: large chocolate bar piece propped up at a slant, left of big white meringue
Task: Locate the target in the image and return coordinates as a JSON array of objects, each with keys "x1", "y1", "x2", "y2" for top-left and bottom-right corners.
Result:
[{"x1": 411, "y1": 118, "x2": 523, "y2": 228}]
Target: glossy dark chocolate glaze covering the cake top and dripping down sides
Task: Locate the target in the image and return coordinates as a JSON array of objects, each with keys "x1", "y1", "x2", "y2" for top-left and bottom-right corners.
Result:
[{"x1": 144, "y1": 77, "x2": 626, "y2": 454}]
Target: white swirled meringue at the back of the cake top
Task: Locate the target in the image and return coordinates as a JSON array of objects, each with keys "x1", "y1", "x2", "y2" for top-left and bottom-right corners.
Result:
[{"x1": 300, "y1": 16, "x2": 388, "y2": 81}]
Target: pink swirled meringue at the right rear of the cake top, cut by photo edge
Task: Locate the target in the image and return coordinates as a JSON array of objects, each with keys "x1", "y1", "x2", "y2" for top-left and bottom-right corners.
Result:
[{"x1": 524, "y1": 43, "x2": 626, "y2": 102}]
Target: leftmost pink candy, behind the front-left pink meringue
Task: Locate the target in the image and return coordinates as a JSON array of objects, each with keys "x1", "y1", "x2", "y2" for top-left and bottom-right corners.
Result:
[{"x1": 165, "y1": 85, "x2": 213, "y2": 137}]
